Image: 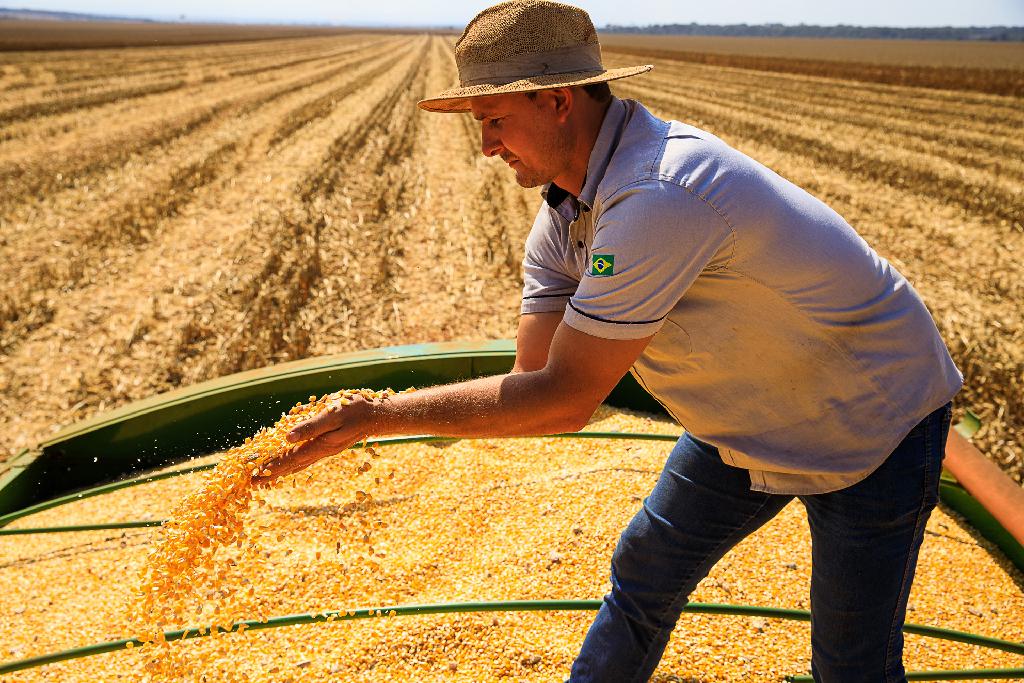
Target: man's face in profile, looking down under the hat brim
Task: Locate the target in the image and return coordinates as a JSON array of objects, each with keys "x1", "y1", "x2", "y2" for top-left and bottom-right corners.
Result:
[{"x1": 470, "y1": 91, "x2": 570, "y2": 187}]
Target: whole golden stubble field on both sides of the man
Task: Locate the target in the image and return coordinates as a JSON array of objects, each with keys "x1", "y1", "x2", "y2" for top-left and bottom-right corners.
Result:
[{"x1": 0, "y1": 34, "x2": 1024, "y2": 480}]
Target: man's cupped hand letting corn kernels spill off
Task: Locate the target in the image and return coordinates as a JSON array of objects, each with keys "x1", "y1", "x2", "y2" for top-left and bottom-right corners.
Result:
[{"x1": 253, "y1": 396, "x2": 374, "y2": 486}]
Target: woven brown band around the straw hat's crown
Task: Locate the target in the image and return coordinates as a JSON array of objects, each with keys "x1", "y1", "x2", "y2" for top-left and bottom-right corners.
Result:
[{"x1": 459, "y1": 43, "x2": 604, "y2": 88}]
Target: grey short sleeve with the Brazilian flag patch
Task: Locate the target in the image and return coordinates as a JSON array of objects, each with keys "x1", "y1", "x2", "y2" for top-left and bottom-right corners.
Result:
[{"x1": 564, "y1": 179, "x2": 732, "y2": 339}]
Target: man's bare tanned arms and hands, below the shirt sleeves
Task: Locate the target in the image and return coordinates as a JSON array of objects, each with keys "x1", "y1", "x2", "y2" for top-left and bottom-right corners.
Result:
[{"x1": 260, "y1": 316, "x2": 650, "y2": 480}]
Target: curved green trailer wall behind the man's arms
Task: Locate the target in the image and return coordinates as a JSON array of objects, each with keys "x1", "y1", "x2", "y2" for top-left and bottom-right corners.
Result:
[{"x1": 0, "y1": 340, "x2": 1024, "y2": 570}]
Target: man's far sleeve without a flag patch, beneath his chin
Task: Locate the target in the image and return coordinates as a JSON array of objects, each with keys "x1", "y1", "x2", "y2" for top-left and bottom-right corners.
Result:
[{"x1": 520, "y1": 204, "x2": 579, "y2": 313}]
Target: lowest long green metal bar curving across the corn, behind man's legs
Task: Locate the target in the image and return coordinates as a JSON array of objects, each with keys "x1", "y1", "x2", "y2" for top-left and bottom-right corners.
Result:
[{"x1": 0, "y1": 600, "x2": 1024, "y2": 680}]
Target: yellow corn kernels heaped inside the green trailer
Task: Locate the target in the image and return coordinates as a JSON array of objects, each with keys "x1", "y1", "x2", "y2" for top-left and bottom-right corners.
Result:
[{"x1": 0, "y1": 408, "x2": 1024, "y2": 683}]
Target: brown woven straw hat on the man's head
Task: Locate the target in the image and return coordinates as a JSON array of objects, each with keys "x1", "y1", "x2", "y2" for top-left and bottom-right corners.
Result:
[{"x1": 419, "y1": 0, "x2": 652, "y2": 112}]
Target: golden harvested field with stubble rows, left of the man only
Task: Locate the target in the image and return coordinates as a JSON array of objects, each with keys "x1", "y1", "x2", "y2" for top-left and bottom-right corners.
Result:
[{"x1": 0, "y1": 34, "x2": 536, "y2": 466}]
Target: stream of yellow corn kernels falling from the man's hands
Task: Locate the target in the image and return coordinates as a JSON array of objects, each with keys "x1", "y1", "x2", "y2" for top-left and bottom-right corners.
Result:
[{"x1": 128, "y1": 389, "x2": 394, "y2": 677}]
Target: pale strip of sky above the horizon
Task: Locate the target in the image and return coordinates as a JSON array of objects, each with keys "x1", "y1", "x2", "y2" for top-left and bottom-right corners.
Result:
[{"x1": 8, "y1": 0, "x2": 1024, "y2": 28}]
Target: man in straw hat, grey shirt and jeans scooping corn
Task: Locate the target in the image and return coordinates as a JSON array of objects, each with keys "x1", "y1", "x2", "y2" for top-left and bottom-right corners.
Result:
[{"x1": 256, "y1": 0, "x2": 962, "y2": 683}]
